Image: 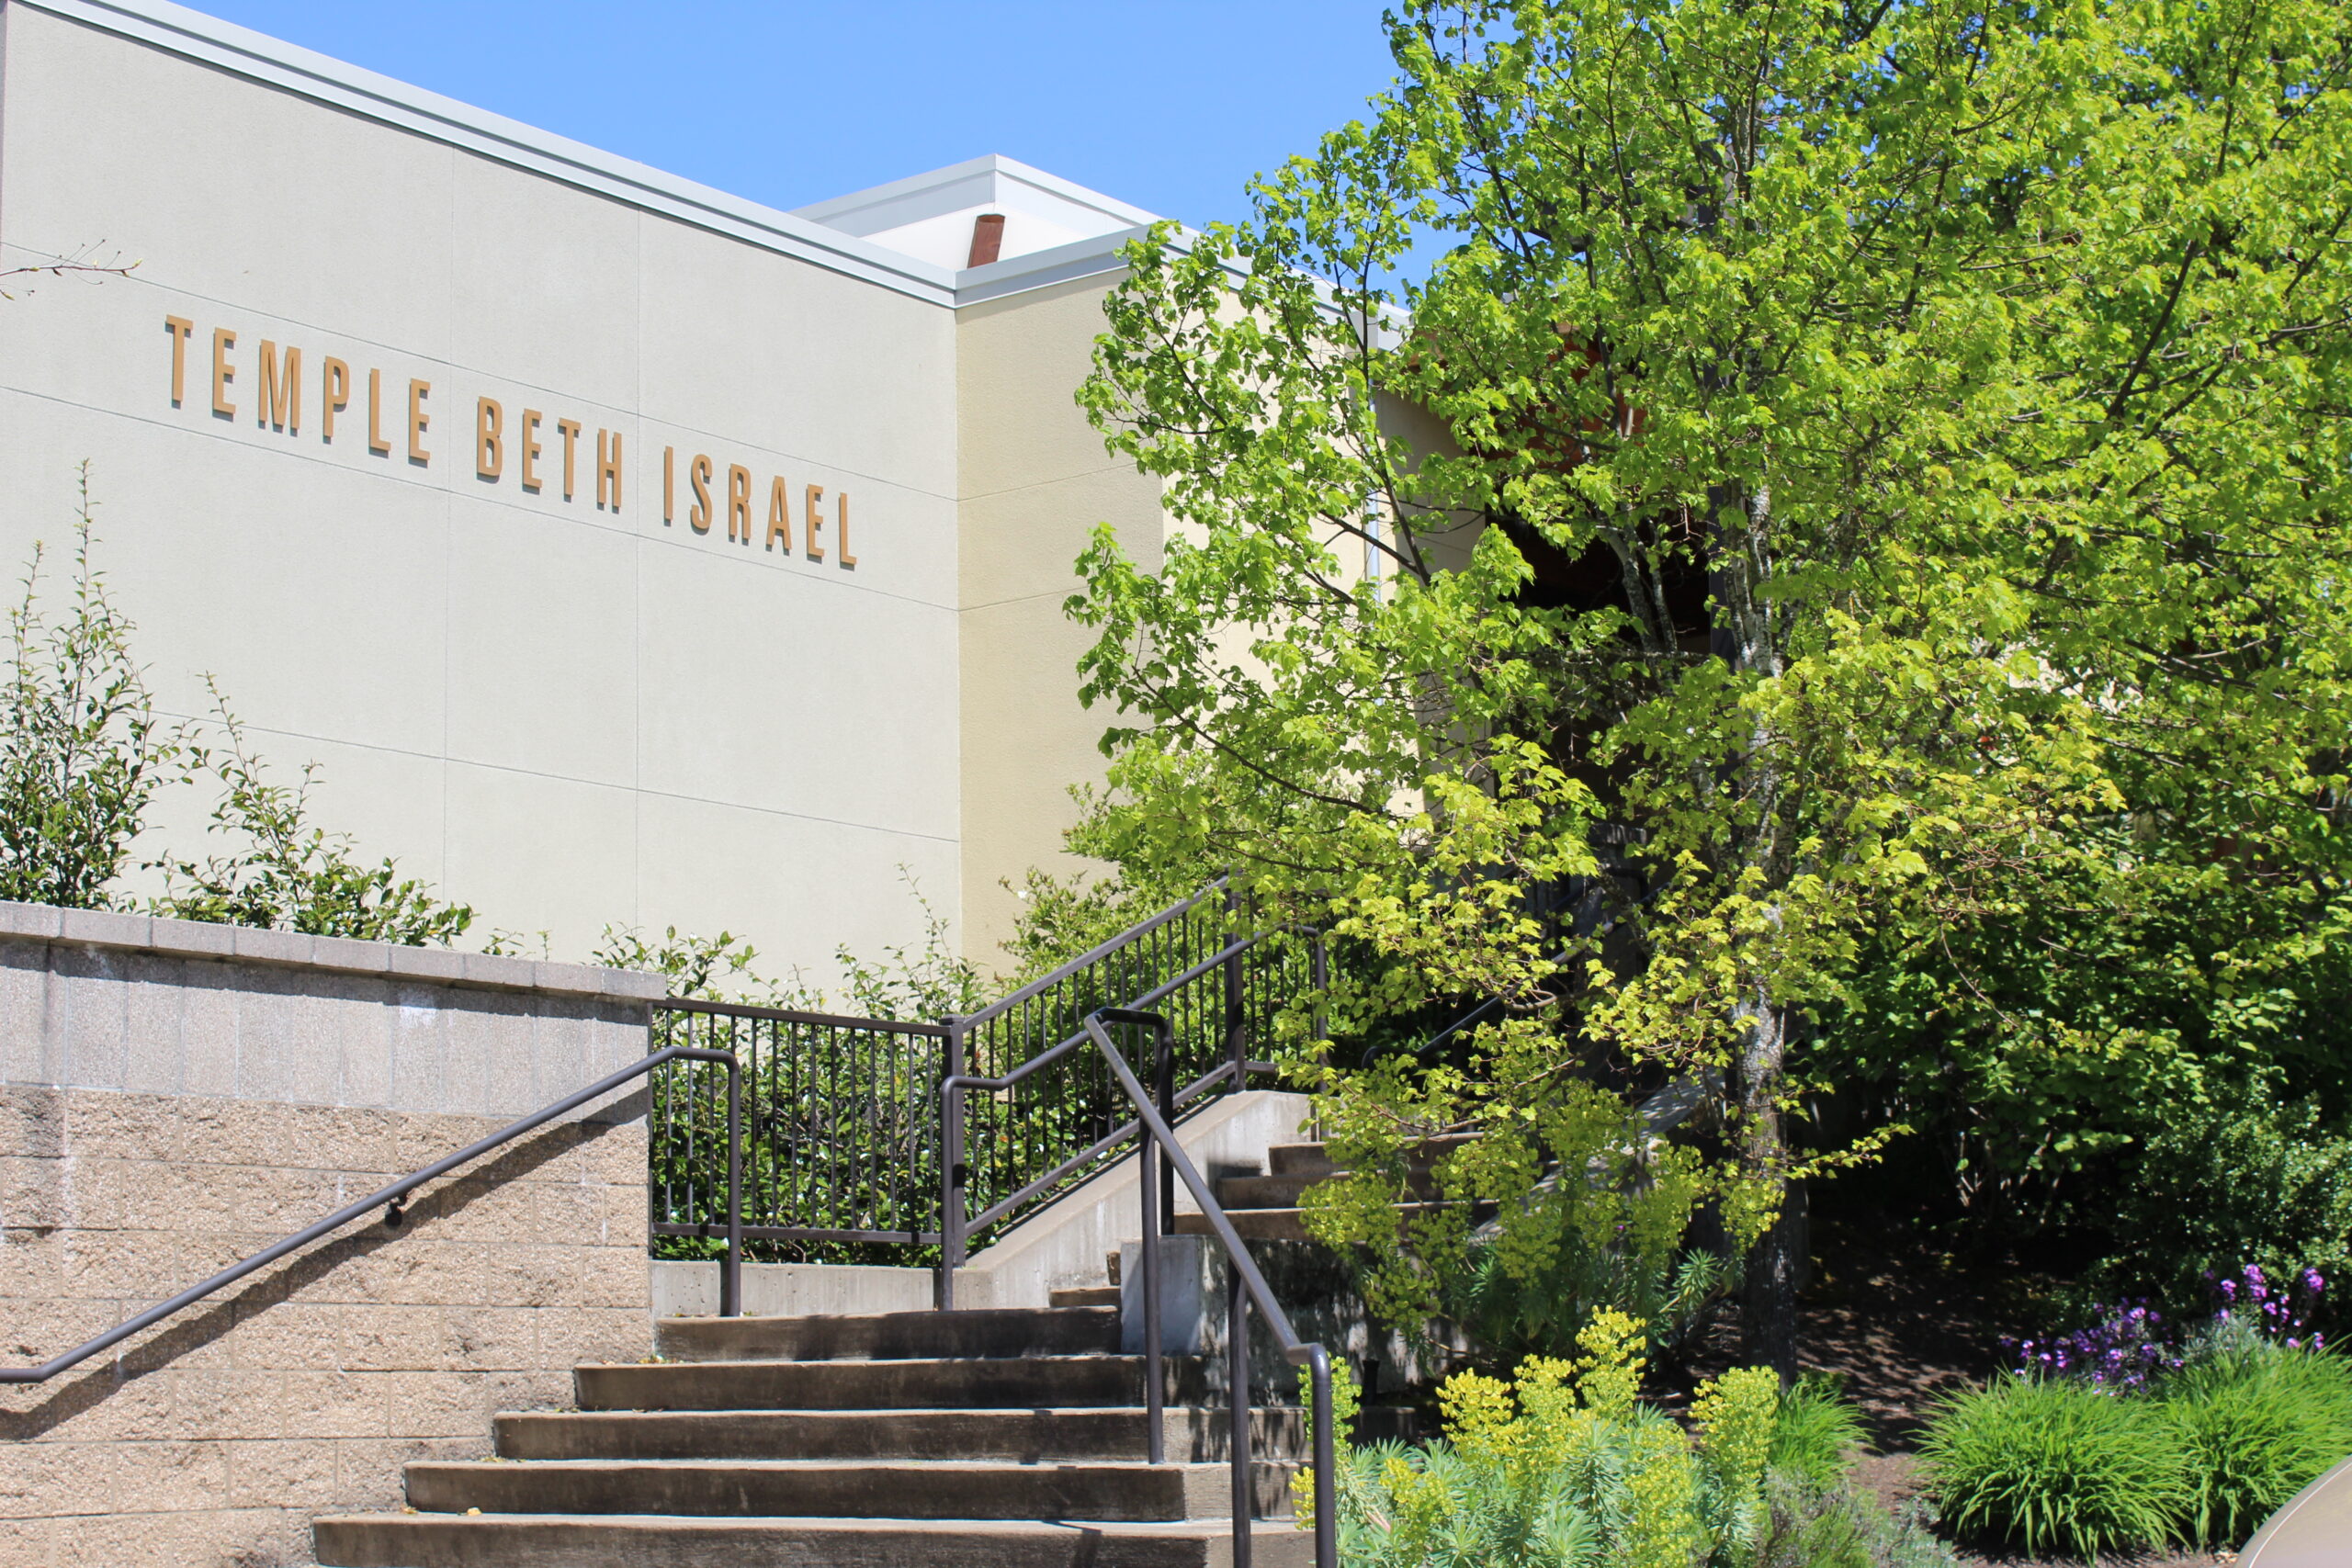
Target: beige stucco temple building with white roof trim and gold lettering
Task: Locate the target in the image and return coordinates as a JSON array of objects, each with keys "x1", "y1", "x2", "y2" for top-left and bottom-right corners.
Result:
[{"x1": 0, "y1": 0, "x2": 1162, "y2": 974}]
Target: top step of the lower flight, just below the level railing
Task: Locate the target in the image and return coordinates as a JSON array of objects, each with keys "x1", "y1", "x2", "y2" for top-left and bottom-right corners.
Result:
[{"x1": 654, "y1": 1300, "x2": 1120, "y2": 1361}]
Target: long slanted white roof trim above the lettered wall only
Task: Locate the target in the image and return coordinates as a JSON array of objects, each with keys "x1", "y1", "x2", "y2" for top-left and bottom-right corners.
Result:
[{"x1": 0, "y1": 0, "x2": 957, "y2": 306}]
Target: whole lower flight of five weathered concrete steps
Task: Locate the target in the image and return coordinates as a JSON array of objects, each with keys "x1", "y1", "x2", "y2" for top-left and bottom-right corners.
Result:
[{"x1": 312, "y1": 1304, "x2": 1312, "y2": 1568}]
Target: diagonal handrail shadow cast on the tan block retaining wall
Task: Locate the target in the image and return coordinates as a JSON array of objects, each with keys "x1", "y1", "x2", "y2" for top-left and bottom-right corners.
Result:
[{"x1": 0, "y1": 1089, "x2": 650, "y2": 1441}]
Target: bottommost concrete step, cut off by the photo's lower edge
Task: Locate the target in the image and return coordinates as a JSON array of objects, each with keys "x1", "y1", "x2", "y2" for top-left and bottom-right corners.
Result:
[{"x1": 312, "y1": 1514, "x2": 1315, "y2": 1568}]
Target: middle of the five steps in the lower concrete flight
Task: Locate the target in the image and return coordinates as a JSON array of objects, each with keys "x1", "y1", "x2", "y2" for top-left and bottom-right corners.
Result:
[{"x1": 496, "y1": 1405, "x2": 1306, "y2": 1462}]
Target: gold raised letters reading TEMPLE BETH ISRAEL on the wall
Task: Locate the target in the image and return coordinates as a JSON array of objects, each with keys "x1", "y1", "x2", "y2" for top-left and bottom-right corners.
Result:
[{"x1": 163, "y1": 315, "x2": 858, "y2": 569}]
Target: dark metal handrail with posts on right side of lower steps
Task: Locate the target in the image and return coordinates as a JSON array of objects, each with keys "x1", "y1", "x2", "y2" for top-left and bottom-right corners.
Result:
[{"x1": 941, "y1": 1006, "x2": 1339, "y2": 1568}]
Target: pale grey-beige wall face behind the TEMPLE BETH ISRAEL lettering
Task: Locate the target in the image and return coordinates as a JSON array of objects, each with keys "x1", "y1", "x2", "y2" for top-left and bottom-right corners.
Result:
[{"x1": 0, "y1": 3, "x2": 962, "y2": 966}]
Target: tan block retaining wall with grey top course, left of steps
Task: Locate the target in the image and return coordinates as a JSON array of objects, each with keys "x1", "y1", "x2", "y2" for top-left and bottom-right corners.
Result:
[{"x1": 0, "y1": 905, "x2": 661, "y2": 1568}]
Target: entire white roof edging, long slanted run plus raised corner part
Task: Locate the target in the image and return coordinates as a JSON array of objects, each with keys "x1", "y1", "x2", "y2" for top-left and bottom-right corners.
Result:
[{"x1": 14, "y1": 0, "x2": 1150, "y2": 306}]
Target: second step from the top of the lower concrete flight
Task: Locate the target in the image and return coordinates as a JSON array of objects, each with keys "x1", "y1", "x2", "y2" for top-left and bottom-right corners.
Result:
[{"x1": 571, "y1": 1354, "x2": 1204, "y2": 1411}]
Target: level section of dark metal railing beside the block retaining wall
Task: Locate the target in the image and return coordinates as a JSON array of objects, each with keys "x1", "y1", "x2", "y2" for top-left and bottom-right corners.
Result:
[{"x1": 647, "y1": 999, "x2": 948, "y2": 1262}]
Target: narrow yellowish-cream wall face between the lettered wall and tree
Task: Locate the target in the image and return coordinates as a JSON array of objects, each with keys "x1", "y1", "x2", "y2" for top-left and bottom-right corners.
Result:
[{"x1": 957, "y1": 275, "x2": 1164, "y2": 962}]
